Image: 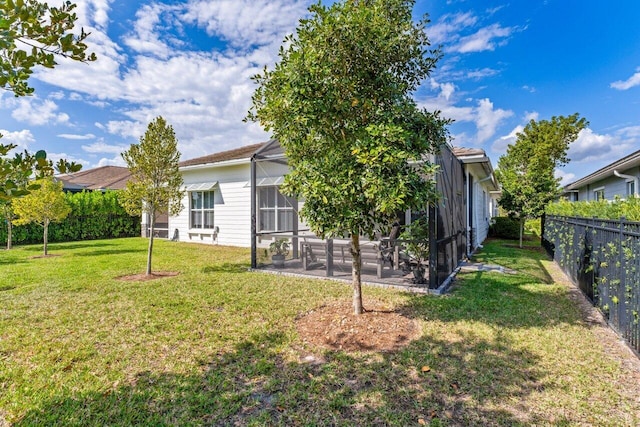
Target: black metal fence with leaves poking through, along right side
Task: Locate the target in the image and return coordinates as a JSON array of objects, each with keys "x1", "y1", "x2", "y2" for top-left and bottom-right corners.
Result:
[{"x1": 542, "y1": 215, "x2": 640, "y2": 351}]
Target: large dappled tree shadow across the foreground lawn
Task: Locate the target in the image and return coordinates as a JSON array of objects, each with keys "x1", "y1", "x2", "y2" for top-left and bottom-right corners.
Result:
[{"x1": 15, "y1": 326, "x2": 545, "y2": 426}]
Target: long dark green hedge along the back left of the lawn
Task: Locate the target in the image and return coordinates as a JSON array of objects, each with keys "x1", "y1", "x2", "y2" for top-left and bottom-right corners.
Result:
[{"x1": 0, "y1": 191, "x2": 140, "y2": 245}]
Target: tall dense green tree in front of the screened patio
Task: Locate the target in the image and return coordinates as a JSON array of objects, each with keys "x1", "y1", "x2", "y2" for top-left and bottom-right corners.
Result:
[{"x1": 248, "y1": 0, "x2": 448, "y2": 314}]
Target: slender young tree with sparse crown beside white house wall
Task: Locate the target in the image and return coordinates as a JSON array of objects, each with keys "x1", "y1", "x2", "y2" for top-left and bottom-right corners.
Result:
[{"x1": 122, "y1": 117, "x2": 184, "y2": 274}]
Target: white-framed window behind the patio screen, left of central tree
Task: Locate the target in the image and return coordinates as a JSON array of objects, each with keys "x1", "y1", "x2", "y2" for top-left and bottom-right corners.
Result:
[{"x1": 258, "y1": 185, "x2": 294, "y2": 231}]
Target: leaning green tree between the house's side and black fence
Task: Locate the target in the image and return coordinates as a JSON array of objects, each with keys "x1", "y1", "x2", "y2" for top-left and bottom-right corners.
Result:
[{"x1": 496, "y1": 113, "x2": 589, "y2": 247}]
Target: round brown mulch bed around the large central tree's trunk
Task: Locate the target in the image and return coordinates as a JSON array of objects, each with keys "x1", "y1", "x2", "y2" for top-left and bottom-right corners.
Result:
[{"x1": 296, "y1": 301, "x2": 420, "y2": 352}]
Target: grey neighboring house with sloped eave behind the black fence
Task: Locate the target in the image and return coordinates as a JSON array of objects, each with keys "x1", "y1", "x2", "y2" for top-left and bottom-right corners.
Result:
[{"x1": 563, "y1": 150, "x2": 640, "y2": 202}]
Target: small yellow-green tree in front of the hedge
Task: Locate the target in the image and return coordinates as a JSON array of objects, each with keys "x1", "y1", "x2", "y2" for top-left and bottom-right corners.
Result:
[{"x1": 13, "y1": 177, "x2": 71, "y2": 256}]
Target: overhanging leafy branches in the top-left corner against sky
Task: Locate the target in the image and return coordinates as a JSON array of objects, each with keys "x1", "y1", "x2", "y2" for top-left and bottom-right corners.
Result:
[{"x1": 0, "y1": 0, "x2": 96, "y2": 96}]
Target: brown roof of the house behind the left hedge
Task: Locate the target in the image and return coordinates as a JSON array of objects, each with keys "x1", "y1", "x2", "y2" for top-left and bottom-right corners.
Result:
[{"x1": 56, "y1": 166, "x2": 131, "y2": 191}]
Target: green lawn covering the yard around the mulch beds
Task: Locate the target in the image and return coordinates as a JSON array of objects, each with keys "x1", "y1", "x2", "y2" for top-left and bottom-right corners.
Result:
[{"x1": 0, "y1": 238, "x2": 640, "y2": 426}]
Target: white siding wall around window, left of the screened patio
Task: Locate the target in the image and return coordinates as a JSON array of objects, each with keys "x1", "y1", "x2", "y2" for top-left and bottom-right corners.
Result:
[{"x1": 169, "y1": 161, "x2": 251, "y2": 247}]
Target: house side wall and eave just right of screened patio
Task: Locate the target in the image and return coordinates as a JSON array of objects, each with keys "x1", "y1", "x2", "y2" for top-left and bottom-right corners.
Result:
[{"x1": 452, "y1": 147, "x2": 499, "y2": 253}]
